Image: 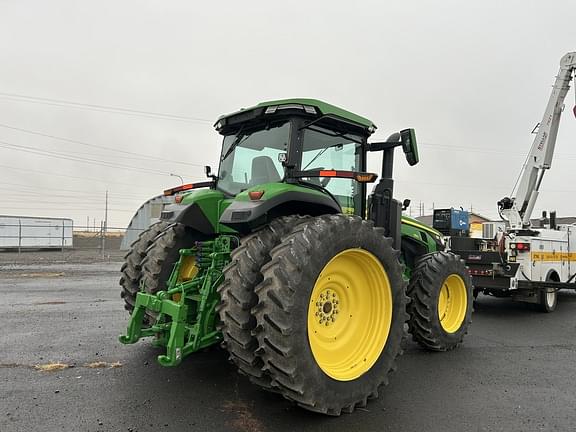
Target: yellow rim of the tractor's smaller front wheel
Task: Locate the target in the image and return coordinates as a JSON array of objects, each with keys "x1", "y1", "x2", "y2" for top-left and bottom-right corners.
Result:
[{"x1": 438, "y1": 274, "x2": 468, "y2": 333}]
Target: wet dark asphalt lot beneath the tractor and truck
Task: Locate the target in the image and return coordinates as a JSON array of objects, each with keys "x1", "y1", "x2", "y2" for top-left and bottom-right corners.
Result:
[{"x1": 0, "y1": 263, "x2": 576, "y2": 432}]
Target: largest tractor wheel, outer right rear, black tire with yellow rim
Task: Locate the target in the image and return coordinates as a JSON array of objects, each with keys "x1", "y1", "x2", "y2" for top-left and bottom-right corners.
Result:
[{"x1": 252, "y1": 214, "x2": 407, "y2": 415}]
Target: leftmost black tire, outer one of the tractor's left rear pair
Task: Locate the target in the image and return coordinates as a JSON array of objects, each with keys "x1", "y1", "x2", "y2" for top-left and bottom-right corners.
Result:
[{"x1": 120, "y1": 221, "x2": 168, "y2": 312}]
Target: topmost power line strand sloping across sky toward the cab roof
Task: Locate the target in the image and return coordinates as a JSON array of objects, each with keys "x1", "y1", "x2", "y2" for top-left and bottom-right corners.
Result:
[{"x1": 0, "y1": 92, "x2": 212, "y2": 123}]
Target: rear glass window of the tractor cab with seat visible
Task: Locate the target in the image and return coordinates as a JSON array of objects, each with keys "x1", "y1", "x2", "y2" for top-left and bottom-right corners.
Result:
[{"x1": 218, "y1": 120, "x2": 290, "y2": 195}]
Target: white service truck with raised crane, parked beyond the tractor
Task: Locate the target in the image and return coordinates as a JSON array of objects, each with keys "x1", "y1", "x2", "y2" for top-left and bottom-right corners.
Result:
[{"x1": 451, "y1": 52, "x2": 576, "y2": 312}]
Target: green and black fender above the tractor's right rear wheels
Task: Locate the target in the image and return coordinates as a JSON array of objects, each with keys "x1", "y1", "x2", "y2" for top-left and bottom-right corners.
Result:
[{"x1": 220, "y1": 183, "x2": 342, "y2": 232}]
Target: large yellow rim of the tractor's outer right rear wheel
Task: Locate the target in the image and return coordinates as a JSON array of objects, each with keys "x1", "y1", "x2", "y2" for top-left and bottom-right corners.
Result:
[{"x1": 308, "y1": 249, "x2": 392, "y2": 381}]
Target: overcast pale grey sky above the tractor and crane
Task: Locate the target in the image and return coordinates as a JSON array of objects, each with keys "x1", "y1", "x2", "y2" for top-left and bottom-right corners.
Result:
[{"x1": 0, "y1": 0, "x2": 576, "y2": 226}]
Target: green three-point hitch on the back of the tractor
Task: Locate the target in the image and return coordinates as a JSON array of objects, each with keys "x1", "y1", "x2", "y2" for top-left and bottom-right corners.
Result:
[{"x1": 120, "y1": 235, "x2": 238, "y2": 366}]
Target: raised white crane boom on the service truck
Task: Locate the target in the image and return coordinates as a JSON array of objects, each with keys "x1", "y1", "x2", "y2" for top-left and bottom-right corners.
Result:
[{"x1": 498, "y1": 52, "x2": 576, "y2": 230}]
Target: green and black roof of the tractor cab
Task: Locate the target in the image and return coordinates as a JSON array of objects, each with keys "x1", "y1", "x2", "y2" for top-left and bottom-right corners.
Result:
[{"x1": 216, "y1": 98, "x2": 376, "y2": 134}]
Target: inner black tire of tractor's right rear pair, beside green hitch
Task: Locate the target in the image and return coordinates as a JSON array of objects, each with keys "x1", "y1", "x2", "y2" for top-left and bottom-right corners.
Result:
[{"x1": 218, "y1": 216, "x2": 305, "y2": 388}]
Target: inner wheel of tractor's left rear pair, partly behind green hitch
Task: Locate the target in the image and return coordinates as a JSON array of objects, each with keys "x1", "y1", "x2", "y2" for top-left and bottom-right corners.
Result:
[{"x1": 141, "y1": 223, "x2": 206, "y2": 321}]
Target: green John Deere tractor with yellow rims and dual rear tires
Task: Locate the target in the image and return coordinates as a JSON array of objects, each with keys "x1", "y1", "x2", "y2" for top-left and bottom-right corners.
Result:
[{"x1": 120, "y1": 99, "x2": 472, "y2": 415}]
